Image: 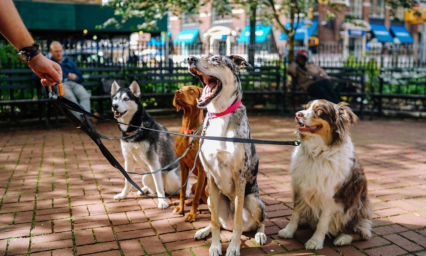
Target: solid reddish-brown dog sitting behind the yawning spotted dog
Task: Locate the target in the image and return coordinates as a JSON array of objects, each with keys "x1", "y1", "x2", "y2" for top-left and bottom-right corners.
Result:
[{"x1": 173, "y1": 86, "x2": 207, "y2": 222}]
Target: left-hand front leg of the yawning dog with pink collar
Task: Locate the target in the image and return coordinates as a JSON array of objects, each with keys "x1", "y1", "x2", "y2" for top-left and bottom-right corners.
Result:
[{"x1": 208, "y1": 177, "x2": 222, "y2": 256}]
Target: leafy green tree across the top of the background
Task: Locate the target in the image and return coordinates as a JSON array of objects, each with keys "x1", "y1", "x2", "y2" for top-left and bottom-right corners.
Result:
[{"x1": 104, "y1": 0, "x2": 413, "y2": 64}]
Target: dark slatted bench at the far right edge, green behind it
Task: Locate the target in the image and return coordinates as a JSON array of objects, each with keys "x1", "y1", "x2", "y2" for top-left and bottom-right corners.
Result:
[{"x1": 371, "y1": 68, "x2": 426, "y2": 117}]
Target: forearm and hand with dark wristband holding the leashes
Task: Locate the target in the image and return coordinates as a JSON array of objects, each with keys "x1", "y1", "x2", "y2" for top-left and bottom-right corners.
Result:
[{"x1": 0, "y1": 0, "x2": 62, "y2": 86}]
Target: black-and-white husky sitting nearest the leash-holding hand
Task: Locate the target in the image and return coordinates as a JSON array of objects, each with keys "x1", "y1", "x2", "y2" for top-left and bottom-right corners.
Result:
[{"x1": 111, "y1": 81, "x2": 180, "y2": 209}]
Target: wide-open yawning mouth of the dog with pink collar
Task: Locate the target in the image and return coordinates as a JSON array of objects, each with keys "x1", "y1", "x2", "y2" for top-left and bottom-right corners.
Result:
[{"x1": 189, "y1": 67, "x2": 222, "y2": 107}]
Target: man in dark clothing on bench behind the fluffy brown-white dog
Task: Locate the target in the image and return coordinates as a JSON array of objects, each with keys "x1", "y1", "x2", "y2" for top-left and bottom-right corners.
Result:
[{"x1": 288, "y1": 49, "x2": 340, "y2": 103}]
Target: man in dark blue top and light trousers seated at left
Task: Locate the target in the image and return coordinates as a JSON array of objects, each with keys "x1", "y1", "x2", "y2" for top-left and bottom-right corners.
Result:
[{"x1": 50, "y1": 41, "x2": 94, "y2": 123}]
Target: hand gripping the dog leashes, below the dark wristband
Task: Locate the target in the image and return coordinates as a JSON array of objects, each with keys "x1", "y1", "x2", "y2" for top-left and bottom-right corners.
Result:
[{"x1": 28, "y1": 53, "x2": 62, "y2": 86}]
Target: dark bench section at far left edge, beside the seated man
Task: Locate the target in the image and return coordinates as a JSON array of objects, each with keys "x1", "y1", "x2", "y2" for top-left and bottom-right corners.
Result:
[{"x1": 0, "y1": 69, "x2": 49, "y2": 127}]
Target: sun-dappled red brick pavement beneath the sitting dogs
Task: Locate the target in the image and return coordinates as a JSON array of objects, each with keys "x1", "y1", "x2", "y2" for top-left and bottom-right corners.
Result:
[{"x1": 0, "y1": 117, "x2": 426, "y2": 256}]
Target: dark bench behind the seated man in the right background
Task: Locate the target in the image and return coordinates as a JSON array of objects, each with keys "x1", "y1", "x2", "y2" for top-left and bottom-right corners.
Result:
[{"x1": 286, "y1": 67, "x2": 366, "y2": 119}]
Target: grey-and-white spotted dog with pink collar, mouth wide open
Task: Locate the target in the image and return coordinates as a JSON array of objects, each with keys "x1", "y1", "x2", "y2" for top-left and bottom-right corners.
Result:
[{"x1": 188, "y1": 55, "x2": 267, "y2": 256}]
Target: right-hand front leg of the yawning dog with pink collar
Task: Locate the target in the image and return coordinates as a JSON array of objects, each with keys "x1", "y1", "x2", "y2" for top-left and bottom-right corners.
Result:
[{"x1": 226, "y1": 180, "x2": 246, "y2": 256}]
